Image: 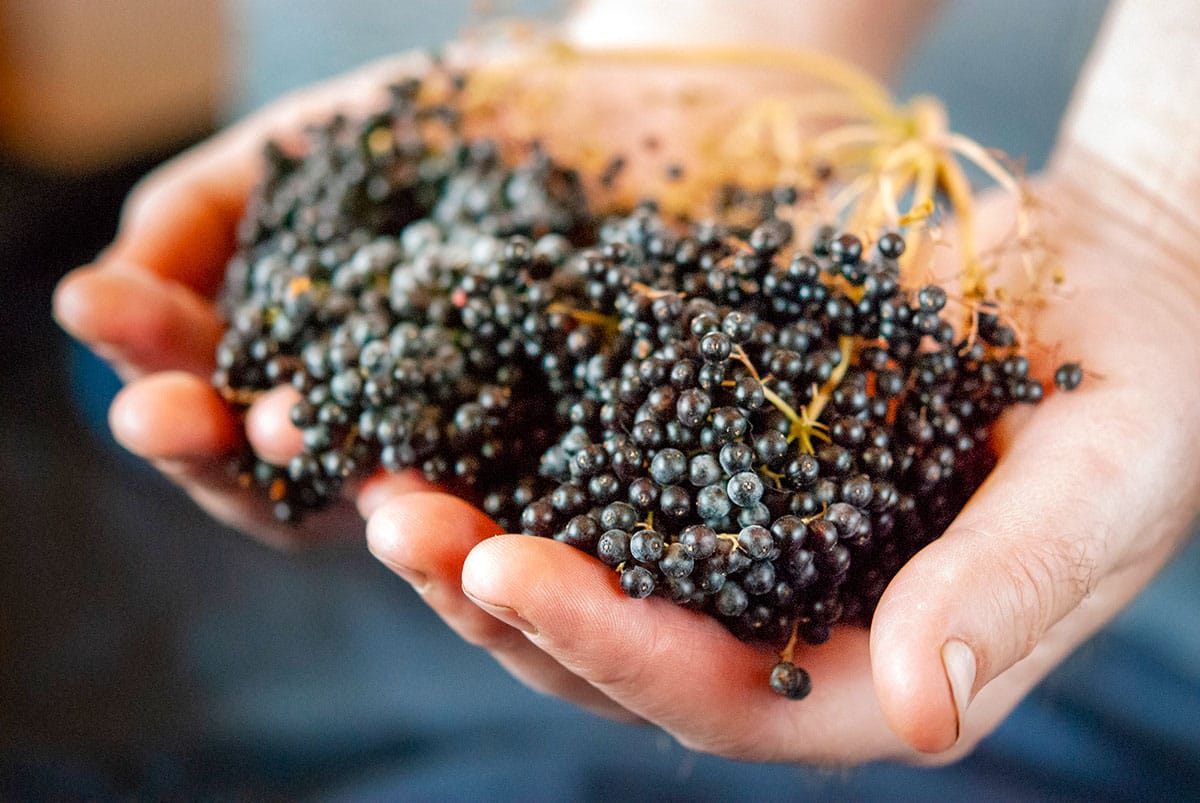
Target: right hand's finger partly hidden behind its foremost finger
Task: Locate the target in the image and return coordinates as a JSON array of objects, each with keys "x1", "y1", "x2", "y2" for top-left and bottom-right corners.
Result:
[{"x1": 367, "y1": 493, "x2": 643, "y2": 719}]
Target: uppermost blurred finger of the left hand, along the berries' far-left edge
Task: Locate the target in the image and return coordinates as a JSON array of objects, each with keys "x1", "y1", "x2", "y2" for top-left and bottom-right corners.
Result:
[{"x1": 102, "y1": 54, "x2": 430, "y2": 296}]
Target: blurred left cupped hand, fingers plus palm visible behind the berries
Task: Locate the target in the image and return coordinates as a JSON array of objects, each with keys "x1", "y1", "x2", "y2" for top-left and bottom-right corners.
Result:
[{"x1": 54, "y1": 42, "x2": 892, "y2": 545}]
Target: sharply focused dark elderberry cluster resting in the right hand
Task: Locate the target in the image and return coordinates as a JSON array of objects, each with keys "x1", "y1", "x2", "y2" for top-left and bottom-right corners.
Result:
[{"x1": 511, "y1": 210, "x2": 1065, "y2": 697}]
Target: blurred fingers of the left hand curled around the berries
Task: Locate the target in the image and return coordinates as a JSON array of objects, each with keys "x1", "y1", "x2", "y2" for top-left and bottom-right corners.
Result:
[{"x1": 54, "y1": 54, "x2": 441, "y2": 545}]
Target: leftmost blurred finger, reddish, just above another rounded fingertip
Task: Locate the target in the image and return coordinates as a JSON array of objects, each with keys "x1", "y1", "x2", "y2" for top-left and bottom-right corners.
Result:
[{"x1": 54, "y1": 263, "x2": 223, "y2": 379}]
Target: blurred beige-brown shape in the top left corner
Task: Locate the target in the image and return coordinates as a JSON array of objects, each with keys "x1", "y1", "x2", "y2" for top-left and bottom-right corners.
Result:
[{"x1": 0, "y1": 0, "x2": 227, "y2": 172}]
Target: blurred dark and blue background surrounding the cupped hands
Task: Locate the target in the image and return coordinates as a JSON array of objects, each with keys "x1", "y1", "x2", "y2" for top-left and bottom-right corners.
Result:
[{"x1": 0, "y1": 0, "x2": 1200, "y2": 801}]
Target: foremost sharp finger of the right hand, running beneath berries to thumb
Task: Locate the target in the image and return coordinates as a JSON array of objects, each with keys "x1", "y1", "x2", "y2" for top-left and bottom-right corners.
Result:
[{"x1": 463, "y1": 535, "x2": 902, "y2": 765}]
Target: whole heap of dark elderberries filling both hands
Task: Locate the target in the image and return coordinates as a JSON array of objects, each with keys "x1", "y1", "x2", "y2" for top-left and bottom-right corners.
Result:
[{"x1": 208, "y1": 76, "x2": 1079, "y2": 699}]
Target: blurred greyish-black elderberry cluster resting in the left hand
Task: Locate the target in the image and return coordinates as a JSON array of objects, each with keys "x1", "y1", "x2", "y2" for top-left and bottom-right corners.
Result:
[{"x1": 215, "y1": 82, "x2": 594, "y2": 527}]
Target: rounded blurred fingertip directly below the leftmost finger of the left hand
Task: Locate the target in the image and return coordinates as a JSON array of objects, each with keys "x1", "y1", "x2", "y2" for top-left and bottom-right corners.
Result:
[{"x1": 108, "y1": 371, "x2": 241, "y2": 461}]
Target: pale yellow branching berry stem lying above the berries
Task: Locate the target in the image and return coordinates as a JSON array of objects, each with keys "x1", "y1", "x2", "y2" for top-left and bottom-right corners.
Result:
[{"x1": 463, "y1": 37, "x2": 1040, "y2": 324}]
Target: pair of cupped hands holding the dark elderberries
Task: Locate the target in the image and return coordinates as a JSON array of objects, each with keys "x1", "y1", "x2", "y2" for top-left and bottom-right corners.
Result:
[{"x1": 54, "y1": 48, "x2": 1200, "y2": 766}]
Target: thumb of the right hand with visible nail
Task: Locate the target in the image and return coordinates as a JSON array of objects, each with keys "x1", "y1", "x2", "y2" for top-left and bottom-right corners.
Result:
[{"x1": 871, "y1": 397, "x2": 1139, "y2": 753}]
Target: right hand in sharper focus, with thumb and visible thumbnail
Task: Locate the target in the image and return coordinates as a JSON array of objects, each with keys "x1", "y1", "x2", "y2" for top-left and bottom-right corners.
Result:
[{"x1": 368, "y1": 154, "x2": 1200, "y2": 765}]
